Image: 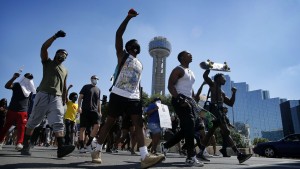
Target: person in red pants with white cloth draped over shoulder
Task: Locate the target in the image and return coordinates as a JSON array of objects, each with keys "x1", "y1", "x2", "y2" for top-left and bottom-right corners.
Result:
[{"x1": 0, "y1": 73, "x2": 36, "y2": 151}]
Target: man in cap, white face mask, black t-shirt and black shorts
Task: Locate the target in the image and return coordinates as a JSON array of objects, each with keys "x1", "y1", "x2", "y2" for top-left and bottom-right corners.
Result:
[{"x1": 78, "y1": 75, "x2": 102, "y2": 153}]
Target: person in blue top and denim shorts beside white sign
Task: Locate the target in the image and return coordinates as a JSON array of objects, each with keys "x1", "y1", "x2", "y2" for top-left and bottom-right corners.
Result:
[{"x1": 146, "y1": 97, "x2": 161, "y2": 154}]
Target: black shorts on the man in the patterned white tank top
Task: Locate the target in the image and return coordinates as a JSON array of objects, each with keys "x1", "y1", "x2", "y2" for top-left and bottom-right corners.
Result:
[{"x1": 108, "y1": 93, "x2": 143, "y2": 118}]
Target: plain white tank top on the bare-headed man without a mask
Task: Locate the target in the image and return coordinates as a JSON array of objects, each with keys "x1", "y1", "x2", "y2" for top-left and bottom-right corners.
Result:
[{"x1": 175, "y1": 66, "x2": 195, "y2": 98}]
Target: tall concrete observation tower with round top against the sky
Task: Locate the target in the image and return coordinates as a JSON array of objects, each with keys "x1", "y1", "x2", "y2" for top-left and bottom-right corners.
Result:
[{"x1": 149, "y1": 36, "x2": 171, "y2": 95}]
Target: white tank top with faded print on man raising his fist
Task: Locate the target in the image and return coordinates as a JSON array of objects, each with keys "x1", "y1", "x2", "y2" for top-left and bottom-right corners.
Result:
[{"x1": 111, "y1": 55, "x2": 143, "y2": 99}]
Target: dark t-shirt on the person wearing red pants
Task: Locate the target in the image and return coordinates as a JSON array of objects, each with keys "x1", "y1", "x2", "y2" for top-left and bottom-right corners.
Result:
[{"x1": 8, "y1": 83, "x2": 29, "y2": 112}]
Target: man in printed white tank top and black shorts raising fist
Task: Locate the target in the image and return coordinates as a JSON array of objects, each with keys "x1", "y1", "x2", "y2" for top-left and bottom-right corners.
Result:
[{"x1": 91, "y1": 9, "x2": 164, "y2": 168}]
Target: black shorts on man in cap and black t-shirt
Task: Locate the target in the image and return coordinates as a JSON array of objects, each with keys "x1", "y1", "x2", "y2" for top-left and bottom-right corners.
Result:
[{"x1": 80, "y1": 110, "x2": 101, "y2": 128}]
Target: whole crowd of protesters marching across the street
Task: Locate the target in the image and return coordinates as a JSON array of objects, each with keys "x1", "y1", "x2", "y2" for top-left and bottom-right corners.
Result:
[{"x1": 0, "y1": 9, "x2": 251, "y2": 168}]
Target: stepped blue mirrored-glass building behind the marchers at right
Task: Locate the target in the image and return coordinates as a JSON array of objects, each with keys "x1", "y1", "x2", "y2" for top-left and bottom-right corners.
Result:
[{"x1": 222, "y1": 75, "x2": 285, "y2": 140}]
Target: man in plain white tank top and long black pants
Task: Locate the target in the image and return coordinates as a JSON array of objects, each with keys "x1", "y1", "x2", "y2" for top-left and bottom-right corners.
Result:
[{"x1": 161, "y1": 51, "x2": 203, "y2": 167}]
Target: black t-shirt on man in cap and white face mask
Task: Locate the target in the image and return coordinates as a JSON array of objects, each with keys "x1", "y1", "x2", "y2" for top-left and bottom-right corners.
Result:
[{"x1": 79, "y1": 84, "x2": 101, "y2": 112}]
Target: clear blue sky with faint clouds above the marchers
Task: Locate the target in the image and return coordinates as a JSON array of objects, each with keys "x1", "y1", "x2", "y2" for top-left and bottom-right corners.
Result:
[{"x1": 0, "y1": 0, "x2": 300, "y2": 100}]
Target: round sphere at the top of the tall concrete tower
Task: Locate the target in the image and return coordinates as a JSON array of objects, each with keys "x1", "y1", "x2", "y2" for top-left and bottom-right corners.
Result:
[{"x1": 149, "y1": 36, "x2": 171, "y2": 57}]
